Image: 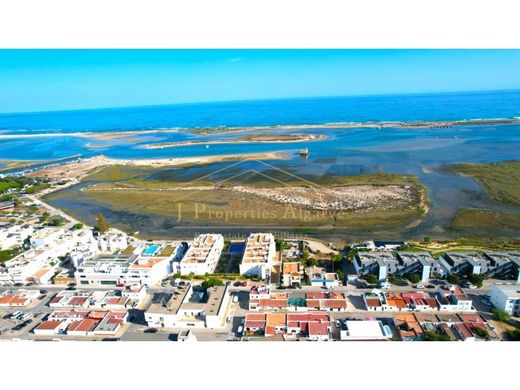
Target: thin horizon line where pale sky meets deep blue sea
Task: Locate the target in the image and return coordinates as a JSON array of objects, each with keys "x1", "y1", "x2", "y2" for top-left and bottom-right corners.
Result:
[{"x1": 0, "y1": 87, "x2": 520, "y2": 116}]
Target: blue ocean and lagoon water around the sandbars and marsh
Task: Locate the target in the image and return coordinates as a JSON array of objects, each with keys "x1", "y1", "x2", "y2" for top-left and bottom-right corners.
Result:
[{"x1": 4, "y1": 90, "x2": 520, "y2": 238}]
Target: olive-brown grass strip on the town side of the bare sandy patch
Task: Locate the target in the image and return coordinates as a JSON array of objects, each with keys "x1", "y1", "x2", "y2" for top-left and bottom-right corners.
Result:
[{"x1": 80, "y1": 189, "x2": 422, "y2": 227}]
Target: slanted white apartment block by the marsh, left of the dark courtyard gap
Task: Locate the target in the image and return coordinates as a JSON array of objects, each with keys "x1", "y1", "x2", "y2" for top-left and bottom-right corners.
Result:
[{"x1": 179, "y1": 234, "x2": 224, "y2": 275}]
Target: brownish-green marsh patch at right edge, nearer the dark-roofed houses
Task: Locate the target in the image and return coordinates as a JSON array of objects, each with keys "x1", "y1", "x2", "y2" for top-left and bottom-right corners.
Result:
[{"x1": 452, "y1": 209, "x2": 520, "y2": 231}]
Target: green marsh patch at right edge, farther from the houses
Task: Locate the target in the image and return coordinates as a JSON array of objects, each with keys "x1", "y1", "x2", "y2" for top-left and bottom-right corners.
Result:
[{"x1": 453, "y1": 161, "x2": 520, "y2": 206}]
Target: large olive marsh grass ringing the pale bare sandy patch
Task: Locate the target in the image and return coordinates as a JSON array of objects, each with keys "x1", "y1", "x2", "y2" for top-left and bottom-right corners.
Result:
[{"x1": 70, "y1": 166, "x2": 428, "y2": 229}]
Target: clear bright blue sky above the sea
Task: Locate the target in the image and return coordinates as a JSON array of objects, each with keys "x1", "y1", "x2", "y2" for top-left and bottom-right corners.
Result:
[{"x1": 0, "y1": 50, "x2": 520, "y2": 113}]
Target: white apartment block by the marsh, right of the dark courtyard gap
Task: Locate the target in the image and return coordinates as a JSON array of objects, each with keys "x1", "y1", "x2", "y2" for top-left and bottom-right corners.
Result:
[{"x1": 240, "y1": 233, "x2": 276, "y2": 283}]
